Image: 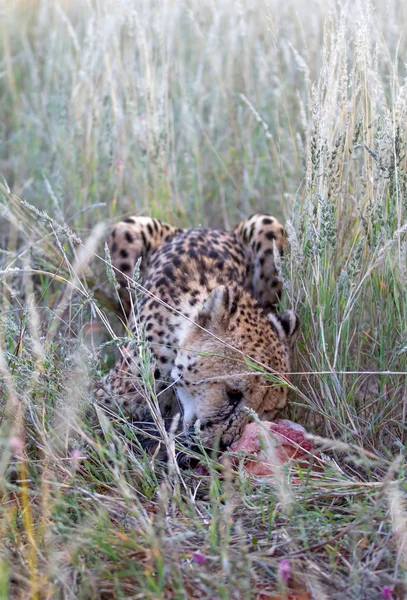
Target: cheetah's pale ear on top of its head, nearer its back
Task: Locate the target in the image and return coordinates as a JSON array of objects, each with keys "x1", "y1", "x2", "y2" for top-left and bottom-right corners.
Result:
[{"x1": 197, "y1": 285, "x2": 240, "y2": 329}]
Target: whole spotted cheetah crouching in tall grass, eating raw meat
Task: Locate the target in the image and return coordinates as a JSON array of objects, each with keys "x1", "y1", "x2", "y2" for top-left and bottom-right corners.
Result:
[{"x1": 98, "y1": 214, "x2": 299, "y2": 448}]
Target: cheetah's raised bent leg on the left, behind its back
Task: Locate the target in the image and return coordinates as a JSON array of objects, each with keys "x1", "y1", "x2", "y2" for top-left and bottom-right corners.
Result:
[{"x1": 109, "y1": 217, "x2": 183, "y2": 317}]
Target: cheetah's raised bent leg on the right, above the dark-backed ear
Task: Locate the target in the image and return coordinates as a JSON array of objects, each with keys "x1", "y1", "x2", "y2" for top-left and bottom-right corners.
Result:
[{"x1": 234, "y1": 215, "x2": 287, "y2": 312}]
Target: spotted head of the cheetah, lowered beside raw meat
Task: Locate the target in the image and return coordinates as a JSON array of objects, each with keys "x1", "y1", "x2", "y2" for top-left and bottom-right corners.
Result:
[{"x1": 171, "y1": 286, "x2": 299, "y2": 448}]
